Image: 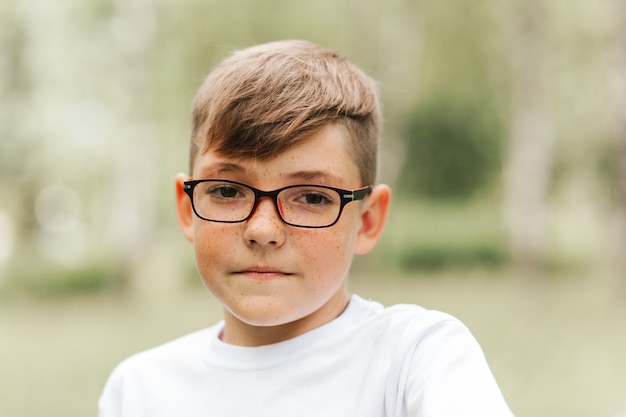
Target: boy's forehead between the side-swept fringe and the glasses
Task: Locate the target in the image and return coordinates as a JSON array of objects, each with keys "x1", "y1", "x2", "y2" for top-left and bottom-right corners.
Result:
[{"x1": 192, "y1": 126, "x2": 361, "y2": 187}]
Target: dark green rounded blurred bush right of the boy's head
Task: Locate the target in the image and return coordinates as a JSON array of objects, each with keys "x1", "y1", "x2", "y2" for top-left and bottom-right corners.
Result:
[{"x1": 398, "y1": 101, "x2": 503, "y2": 200}]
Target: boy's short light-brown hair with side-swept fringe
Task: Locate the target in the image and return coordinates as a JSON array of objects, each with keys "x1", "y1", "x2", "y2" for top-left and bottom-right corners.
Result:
[{"x1": 190, "y1": 40, "x2": 381, "y2": 184}]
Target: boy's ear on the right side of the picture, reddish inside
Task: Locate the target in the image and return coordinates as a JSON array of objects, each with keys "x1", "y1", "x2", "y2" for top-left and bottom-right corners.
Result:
[{"x1": 354, "y1": 184, "x2": 391, "y2": 255}]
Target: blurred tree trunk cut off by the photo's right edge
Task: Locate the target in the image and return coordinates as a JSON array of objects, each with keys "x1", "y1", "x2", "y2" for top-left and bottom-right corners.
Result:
[{"x1": 612, "y1": 0, "x2": 626, "y2": 276}]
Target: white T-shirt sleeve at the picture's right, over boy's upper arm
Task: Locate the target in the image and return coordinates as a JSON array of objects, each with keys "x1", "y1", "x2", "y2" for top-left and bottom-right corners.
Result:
[{"x1": 402, "y1": 318, "x2": 513, "y2": 417}]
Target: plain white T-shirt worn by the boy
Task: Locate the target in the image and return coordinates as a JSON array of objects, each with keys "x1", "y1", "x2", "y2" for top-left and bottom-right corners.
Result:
[{"x1": 99, "y1": 296, "x2": 512, "y2": 417}]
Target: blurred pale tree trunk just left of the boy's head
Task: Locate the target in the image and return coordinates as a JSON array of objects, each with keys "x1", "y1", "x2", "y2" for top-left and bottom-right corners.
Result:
[{"x1": 108, "y1": 0, "x2": 158, "y2": 291}]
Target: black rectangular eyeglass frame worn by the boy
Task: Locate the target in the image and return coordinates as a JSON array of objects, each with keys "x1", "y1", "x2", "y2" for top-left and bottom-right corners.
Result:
[{"x1": 183, "y1": 178, "x2": 372, "y2": 229}]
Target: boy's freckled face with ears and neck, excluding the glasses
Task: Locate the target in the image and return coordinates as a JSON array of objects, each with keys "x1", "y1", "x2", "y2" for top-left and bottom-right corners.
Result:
[{"x1": 177, "y1": 126, "x2": 389, "y2": 345}]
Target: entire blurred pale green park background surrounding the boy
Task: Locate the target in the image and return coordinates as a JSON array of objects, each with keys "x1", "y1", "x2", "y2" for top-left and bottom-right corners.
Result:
[{"x1": 0, "y1": 0, "x2": 626, "y2": 417}]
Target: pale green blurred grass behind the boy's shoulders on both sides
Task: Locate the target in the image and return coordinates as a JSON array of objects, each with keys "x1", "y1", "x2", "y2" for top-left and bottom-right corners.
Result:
[{"x1": 0, "y1": 270, "x2": 626, "y2": 417}]
